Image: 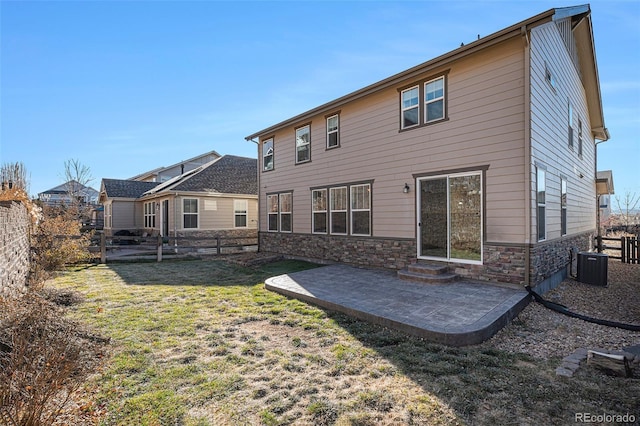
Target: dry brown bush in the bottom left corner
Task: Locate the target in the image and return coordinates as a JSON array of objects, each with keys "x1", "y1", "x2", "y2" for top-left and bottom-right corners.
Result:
[{"x1": 0, "y1": 292, "x2": 105, "y2": 426}]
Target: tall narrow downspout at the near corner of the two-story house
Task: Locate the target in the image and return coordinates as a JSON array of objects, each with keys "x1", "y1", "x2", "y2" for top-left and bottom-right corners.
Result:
[{"x1": 520, "y1": 25, "x2": 531, "y2": 286}]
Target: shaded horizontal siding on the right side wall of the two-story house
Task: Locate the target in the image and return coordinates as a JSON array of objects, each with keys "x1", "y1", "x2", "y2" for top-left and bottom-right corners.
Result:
[{"x1": 531, "y1": 22, "x2": 596, "y2": 241}]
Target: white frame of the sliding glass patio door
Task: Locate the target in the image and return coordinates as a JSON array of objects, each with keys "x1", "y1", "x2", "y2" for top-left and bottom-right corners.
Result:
[{"x1": 414, "y1": 166, "x2": 488, "y2": 265}]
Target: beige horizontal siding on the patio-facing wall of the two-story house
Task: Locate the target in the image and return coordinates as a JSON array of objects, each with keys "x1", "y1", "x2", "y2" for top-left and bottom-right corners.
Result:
[{"x1": 259, "y1": 39, "x2": 525, "y2": 242}]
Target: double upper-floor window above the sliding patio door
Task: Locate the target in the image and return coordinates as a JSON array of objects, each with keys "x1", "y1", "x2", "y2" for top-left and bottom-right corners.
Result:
[{"x1": 400, "y1": 75, "x2": 447, "y2": 129}]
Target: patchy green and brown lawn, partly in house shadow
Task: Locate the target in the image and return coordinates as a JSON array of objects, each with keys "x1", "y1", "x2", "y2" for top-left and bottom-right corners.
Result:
[{"x1": 48, "y1": 261, "x2": 640, "y2": 425}]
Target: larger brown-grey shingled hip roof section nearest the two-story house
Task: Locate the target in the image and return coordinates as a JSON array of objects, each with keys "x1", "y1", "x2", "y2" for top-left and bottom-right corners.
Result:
[{"x1": 169, "y1": 155, "x2": 258, "y2": 195}]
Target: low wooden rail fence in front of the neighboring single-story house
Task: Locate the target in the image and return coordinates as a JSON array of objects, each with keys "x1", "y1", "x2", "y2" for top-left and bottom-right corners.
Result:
[{"x1": 94, "y1": 234, "x2": 258, "y2": 263}]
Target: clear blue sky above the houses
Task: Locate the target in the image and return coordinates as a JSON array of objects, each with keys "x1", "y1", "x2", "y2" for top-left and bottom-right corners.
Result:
[{"x1": 0, "y1": 0, "x2": 640, "y2": 201}]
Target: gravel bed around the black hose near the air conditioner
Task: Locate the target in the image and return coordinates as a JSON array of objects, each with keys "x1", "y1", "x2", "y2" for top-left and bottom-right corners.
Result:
[{"x1": 483, "y1": 259, "x2": 640, "y2": 359}]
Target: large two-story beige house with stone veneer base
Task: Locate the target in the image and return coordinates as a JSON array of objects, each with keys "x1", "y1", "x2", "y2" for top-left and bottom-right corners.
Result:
[{"x1": 246, "y1": 5, "x2": 609, "y2": 286}]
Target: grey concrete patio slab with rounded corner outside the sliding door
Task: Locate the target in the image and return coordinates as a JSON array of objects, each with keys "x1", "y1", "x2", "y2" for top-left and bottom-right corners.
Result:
[{"x1": 265, "y1": 265, "x2": 530, "y2": 346}]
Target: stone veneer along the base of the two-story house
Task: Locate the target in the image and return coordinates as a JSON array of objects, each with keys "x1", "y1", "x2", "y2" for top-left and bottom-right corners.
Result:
[{"x1": 259, "y1": 232, "x2": 594, "y2": 287}]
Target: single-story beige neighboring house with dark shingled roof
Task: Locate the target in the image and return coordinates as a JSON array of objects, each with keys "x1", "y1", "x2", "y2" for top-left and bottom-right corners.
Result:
[{"x1": 100, "y1": 155, "x2": 258, "y2": 237}]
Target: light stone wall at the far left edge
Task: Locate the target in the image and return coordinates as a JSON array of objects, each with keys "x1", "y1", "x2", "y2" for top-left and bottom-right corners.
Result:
[{"x1": 0, "y1": 201, "x2": 30, "y2": 296}]
